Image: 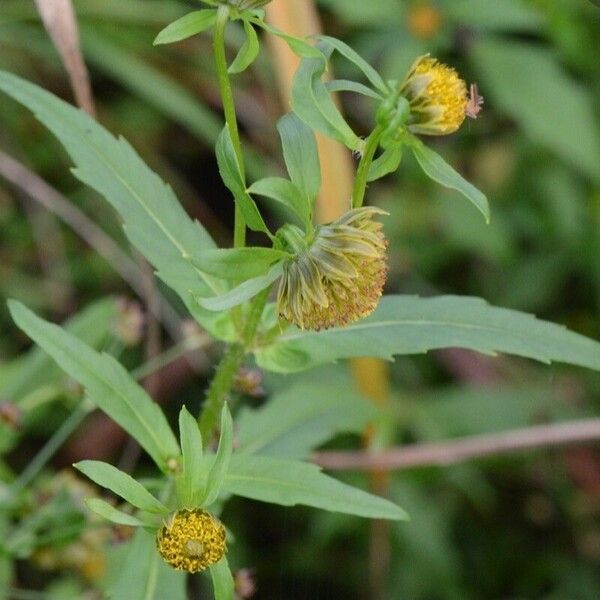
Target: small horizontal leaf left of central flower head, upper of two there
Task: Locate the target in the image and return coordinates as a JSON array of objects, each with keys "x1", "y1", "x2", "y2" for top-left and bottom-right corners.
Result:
[{"x1": 194, "y1": 246, "x2": 291, "y2": 281}]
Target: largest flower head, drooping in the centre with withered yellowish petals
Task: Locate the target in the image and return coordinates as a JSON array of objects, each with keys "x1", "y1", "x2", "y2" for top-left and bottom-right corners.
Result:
[{"x1": 277, "y1": 207, "x2": 387, "y2": 331}]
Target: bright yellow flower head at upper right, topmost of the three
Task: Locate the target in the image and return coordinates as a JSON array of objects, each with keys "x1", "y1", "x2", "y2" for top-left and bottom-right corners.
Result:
[{"x1": 400, "y1": 56, "x2": 467, "y2": 135}]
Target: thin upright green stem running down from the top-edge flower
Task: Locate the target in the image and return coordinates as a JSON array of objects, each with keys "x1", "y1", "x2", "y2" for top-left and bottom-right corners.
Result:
[{"x1": 213, "y1": 5, "x2": 246, "y2": 248}]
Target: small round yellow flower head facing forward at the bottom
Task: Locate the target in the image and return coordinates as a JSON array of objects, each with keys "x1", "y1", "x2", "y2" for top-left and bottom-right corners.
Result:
[{"x1": 156, "y1": 509, "x2": 227, "y2": 573}]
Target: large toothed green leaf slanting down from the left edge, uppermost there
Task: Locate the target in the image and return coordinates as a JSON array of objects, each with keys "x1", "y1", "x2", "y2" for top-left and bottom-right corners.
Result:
[{"x1": 0, "y1": 71, "x2": 230, "y2": 335}]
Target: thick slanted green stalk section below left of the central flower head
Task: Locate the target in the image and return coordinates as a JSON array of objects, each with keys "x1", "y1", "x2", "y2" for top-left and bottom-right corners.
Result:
[{"x1": 198, "y1": 286, "x2": 271, "y2": 445}]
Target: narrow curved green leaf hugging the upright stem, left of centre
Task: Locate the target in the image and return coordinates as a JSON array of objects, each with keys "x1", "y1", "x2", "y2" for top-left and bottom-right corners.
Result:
[{"x1": 216, "y1": 125, "x2": 269, "y2": 234}]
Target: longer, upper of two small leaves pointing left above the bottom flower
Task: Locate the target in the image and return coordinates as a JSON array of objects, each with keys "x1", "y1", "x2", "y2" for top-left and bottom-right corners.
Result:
[{"x1": 73, "y1": 460, "x2": 169, "y2": 514}]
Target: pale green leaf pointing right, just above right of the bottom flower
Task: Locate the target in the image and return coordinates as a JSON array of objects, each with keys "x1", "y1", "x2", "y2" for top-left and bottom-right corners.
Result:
[{"x1": 223, "y1": 454, "x2": 407, "y2": 520}]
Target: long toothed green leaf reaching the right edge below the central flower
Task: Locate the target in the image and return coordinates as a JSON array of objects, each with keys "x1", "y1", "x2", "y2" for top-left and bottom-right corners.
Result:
[{"x1": 256, "y1": 296, "x2": 600, "y2": 373}]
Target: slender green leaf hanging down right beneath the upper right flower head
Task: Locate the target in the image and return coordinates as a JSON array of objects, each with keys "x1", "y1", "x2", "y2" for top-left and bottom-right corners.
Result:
[{"x1": 409, "y1": 137, "x2": 490, "y2": 223}]
